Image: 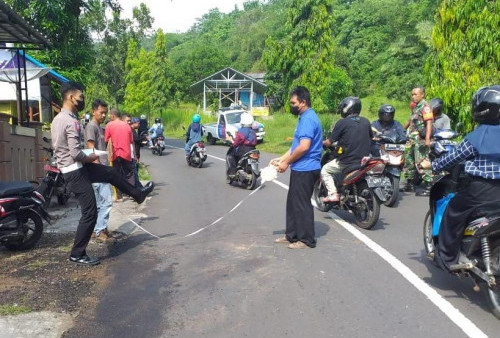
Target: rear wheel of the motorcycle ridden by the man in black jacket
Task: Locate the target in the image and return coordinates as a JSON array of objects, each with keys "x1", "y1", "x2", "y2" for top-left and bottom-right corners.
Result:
[{"x1": 352, "y1": 182, "x2": 380, "y2": 229}]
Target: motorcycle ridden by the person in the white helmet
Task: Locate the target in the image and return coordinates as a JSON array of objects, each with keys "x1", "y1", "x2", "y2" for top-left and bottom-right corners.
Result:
[{"x1": 226, "y1": 132, "x2": 260, "y2": 190}]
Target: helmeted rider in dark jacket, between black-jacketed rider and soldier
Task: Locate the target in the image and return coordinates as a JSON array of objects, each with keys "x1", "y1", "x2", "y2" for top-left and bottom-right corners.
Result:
[{"x1": 372, "y1": 104, "x2": 406, "y2": 156}]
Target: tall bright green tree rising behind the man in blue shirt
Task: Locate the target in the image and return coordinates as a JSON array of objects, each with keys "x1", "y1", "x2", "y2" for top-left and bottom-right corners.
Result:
[{"x1": 263, "y1": 0, "x2": 335, "y2": 112}]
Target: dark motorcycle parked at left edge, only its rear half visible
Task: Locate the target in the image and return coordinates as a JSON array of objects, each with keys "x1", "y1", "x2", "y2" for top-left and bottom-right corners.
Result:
[{"x1": 0, "y1": 182, "x2": 51, "y2": 250}]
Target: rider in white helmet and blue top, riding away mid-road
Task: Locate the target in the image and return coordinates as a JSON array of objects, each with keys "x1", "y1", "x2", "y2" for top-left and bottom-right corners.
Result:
[{"x1": 228, "y1": 113, "x2": 257, "y2": 175}]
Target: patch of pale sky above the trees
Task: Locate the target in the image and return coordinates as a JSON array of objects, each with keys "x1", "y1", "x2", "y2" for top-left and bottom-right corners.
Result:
[{"x1": 120, "y1": 0, "x2": 247, "y2": 33}]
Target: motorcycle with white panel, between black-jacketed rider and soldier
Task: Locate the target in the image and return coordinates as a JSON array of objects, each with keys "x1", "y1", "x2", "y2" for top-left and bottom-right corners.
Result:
[{"x1": 377, "y1": 134, "x2": 406, "y2": 207}]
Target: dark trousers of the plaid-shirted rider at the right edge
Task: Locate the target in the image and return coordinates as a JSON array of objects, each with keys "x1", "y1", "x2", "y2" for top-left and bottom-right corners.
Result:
[{"x1": 438, "y1": 179, "x2": 500, "y2": 269}]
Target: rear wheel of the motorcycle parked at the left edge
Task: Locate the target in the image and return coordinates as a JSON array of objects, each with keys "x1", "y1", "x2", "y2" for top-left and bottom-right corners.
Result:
[{"x1": 5, "y1": 209, "x2": 43, "y2": 250}]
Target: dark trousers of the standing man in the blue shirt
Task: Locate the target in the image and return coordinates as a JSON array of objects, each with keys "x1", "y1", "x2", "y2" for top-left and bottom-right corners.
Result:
[{"x1": 285, "y1": 170, "x2": 320, "y2": 248}]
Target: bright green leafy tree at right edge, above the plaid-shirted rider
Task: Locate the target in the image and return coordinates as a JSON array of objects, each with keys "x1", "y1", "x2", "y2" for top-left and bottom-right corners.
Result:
[{"x1": 426, "y1": 0, "x2": 500, "y2": 130}]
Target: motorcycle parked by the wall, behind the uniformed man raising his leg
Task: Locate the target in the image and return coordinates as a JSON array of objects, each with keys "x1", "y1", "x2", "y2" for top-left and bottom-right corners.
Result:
[{"x1": 37, "y1": 137, "x2": 71, "y2": 209}]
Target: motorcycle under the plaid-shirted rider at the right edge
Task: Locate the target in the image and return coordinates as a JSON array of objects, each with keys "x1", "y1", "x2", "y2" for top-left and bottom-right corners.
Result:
[{"x1": 423, "y1": 165, "x2": 500, "y2": 319}]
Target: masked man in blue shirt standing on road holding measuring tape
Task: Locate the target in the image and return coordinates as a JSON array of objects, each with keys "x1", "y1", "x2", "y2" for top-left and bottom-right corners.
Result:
[{"x1": 271, "y1": 86, "x2": 323, "y2": 249}]
